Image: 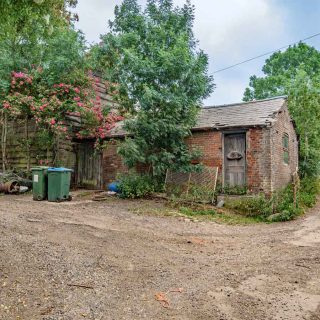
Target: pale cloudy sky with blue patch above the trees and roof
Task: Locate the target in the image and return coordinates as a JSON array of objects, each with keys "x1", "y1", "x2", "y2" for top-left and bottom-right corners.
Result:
[{"x1": 77, "y1": 0, "x2": 320, "y2": 105}]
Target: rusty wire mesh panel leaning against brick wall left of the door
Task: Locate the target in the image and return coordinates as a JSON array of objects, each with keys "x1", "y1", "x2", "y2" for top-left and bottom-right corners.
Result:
[{"x1": 165, "y1": 167, "x2": 218, "y2": 202}]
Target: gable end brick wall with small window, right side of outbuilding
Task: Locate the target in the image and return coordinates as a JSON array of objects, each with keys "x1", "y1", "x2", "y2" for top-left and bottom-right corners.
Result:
[{"x1": 270, "y1": 106, "x2": 298, "y2": 191}]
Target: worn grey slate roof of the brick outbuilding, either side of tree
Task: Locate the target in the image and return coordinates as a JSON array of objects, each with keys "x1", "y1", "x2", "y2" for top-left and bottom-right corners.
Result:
[{"x1": 109, "y1": 96, "x2": 287, "y2": 137}]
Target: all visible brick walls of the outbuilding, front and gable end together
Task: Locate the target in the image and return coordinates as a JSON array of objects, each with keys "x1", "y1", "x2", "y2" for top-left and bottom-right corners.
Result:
[{"x1": 103, "y1": 107, "x2": 298, "y2": 194}]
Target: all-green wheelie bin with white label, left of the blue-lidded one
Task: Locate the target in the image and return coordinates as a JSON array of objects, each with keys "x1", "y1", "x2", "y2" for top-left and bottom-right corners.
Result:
[{"x1": 31, "y1": 166, "x2": 49, "y2": 201}]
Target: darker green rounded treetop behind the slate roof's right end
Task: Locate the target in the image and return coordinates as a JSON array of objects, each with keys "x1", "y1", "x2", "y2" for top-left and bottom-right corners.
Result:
[{"x1": 243, "y1": 42, "x2": 320, "y2": 101}]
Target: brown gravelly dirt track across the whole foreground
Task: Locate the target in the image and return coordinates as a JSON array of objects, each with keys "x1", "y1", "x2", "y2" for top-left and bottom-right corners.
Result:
[{"x1": 0, "y1": 196, "x2": 320, "y2": 320}]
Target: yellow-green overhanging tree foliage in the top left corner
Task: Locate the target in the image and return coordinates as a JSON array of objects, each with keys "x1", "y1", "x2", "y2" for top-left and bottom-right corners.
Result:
[{"x1": 0, "y1": 0, "x2": 77, "y2": 94}]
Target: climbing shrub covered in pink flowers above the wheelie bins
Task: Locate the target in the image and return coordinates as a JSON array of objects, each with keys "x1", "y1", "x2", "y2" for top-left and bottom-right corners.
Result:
[{"x1": 2, "y1": 68, "x2": 122, "y2": 146}]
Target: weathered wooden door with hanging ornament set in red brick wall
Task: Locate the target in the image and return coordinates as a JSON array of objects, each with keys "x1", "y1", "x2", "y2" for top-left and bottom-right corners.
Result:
[{"x1": 224, "y1": 133, "x2": 246, "y2": 187}]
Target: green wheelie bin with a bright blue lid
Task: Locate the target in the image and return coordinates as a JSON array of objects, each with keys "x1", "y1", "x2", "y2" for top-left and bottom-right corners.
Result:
[{"x1": 48, "y1": 168, "x2": 72, "y2": 202}]
